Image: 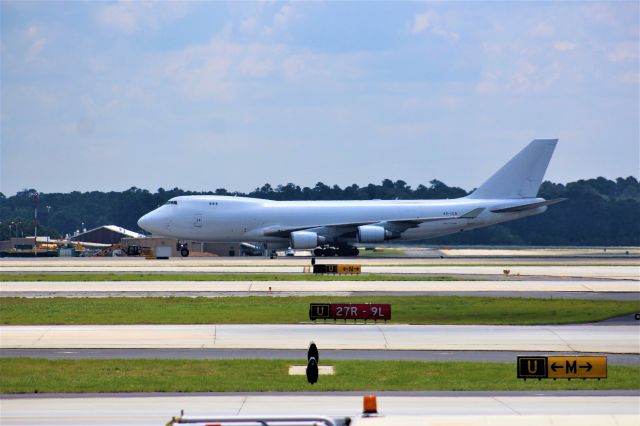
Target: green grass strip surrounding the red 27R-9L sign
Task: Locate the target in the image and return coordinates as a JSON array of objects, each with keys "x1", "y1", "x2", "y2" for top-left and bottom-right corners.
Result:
[{"x1": 0, "y1": 296, "x2": 640, "y2": 325}]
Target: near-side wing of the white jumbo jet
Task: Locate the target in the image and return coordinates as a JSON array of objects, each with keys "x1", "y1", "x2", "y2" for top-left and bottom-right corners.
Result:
[{"x1": 264, "y1": 207, "x2": 484, "y2": 238}]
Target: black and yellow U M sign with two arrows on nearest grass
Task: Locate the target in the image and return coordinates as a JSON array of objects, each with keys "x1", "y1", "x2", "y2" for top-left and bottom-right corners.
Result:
[{"x1": 517, "y1": 356, "x2": 607, "y2": 379}]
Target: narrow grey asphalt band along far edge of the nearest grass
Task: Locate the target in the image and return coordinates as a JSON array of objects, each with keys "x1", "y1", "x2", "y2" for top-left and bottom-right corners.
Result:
[{"x1": 0, "y1": 348, "x2": 640, "y2": 366}]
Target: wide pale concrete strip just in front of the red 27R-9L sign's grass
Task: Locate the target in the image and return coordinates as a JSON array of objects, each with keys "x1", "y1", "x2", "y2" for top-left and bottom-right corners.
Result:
[{"x1": 0, "y1": 324, "x2": 640, "y2": 354}]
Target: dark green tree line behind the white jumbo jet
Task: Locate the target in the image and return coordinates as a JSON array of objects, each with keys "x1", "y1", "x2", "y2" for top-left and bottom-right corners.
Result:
[{"x1": 0, "y1": 176, "x2": 640, "y2": 246}]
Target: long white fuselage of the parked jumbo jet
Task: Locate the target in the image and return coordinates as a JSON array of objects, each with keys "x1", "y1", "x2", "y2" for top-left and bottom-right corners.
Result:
[{"x1": 139, "y1": 195, "x2": 546, "y2": 245}]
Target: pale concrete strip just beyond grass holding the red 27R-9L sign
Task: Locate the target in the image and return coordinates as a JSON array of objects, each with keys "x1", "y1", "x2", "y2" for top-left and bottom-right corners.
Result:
[{"x1": 0, "y1": 280, "x2": 640, "y2": 300}]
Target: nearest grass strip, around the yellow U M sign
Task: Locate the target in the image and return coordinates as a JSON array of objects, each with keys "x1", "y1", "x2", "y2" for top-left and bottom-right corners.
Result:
[{"x1": 0, "y1": 358, "x2": 640, "y2": 393}]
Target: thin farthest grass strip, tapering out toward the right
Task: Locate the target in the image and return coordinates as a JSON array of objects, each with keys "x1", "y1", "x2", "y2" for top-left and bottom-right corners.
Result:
[{"x1": 0, "y1": 272, "x2": 464, "y2": 282}]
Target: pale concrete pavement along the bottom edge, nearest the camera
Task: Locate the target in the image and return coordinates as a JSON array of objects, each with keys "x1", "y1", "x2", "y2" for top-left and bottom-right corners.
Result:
[{"x1": 0, "y1": 392, "x2": 640, "y2": 426}]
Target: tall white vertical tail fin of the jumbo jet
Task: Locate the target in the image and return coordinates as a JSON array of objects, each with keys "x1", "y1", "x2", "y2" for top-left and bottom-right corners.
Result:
[{"x1": 468, "y1": 139, "x2": 558, "y2": 199}]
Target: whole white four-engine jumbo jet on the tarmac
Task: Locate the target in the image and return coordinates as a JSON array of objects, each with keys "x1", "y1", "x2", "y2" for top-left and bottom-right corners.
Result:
[{"x1": 138, "y1": 139, "x2": 564, "y2": 256}]
